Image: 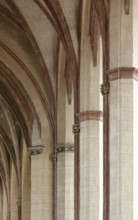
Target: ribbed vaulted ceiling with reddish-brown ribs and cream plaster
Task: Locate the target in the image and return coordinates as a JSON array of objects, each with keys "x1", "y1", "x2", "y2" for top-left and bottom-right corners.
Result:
[{"x1": 0, "y1": 0, "x2": 132, "y2": 210}]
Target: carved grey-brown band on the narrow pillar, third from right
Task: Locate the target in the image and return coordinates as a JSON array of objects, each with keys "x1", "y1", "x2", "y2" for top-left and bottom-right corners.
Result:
[{"x1": 56, "y1": 143, "x2": 74, "y2": 154}]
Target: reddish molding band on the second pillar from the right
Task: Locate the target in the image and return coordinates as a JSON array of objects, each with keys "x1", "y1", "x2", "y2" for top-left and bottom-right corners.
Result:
[{"x1": 76, "y1": 110, "x2": 103, "y2": 122}]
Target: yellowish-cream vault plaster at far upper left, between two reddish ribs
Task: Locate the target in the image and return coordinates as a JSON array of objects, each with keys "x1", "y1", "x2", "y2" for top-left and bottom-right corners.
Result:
[{"x1": 0, "y1": 15, "x2": 45, "y2": 94}]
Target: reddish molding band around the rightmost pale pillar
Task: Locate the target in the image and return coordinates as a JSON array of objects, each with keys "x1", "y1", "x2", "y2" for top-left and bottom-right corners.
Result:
[{"x1": 107, "y1": 67, "x2": 138, "y2": 81}]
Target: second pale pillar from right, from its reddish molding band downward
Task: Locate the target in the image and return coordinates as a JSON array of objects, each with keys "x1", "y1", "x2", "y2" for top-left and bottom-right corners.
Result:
[{"x1": 78, "y1": 111, "x2": 103, "y2": 220}]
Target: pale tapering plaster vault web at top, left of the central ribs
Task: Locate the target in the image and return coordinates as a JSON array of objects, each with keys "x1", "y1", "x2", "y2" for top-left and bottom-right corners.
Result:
[{"x1": 15, "y1": 0, "x2": 57, "y2": 90}]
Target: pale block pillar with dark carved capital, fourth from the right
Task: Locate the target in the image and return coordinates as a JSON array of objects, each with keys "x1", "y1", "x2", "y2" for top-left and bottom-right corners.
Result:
[{"x1": 28, "y1": 145, "x2": 52, "y2": 220}]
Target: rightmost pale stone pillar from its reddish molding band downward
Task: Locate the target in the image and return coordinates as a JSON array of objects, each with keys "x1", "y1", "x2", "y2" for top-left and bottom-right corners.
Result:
[{"x1": 108, "y1": 68, "x2": 138, "y2": 220}]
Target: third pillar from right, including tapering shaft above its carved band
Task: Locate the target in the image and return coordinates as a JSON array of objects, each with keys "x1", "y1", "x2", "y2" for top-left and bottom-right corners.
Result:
[{"x1": 55, "y1": 45, "x2": 74, "y2": 220}]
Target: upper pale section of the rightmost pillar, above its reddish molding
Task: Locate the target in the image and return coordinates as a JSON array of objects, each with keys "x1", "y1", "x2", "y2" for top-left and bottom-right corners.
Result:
[{"x1": 109, "y1": 0, "x2": 133, "y2": 69}]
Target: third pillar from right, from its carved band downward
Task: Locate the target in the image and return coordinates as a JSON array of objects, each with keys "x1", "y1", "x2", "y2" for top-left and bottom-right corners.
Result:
[{"x1": 56, "y1": 144, "x2": 74, "y2": 220}]
